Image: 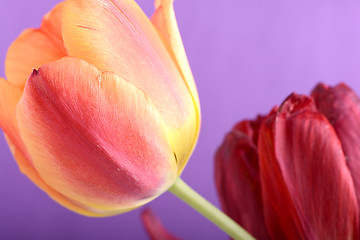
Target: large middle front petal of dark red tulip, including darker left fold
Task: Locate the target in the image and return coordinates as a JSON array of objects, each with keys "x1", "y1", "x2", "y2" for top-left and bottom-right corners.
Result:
[{"x1": 259, "y1": 94, "x2": 359, "y2": 239}]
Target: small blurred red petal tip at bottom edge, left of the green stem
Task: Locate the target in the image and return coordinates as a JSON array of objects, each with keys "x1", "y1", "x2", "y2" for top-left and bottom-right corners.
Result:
[{"x1": 141, "y1": 208, "x2": 178, "y2": 240}]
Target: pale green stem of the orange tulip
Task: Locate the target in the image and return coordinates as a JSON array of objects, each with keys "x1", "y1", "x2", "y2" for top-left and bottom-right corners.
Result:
[{"x1": 169, "y1": 178, "x2": 255, "y2": 240}]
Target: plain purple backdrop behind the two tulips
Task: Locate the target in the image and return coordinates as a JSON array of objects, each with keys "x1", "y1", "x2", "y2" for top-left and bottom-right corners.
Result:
[{"x1": 0, "y1": 0, "x2": 360, "y2": 240}]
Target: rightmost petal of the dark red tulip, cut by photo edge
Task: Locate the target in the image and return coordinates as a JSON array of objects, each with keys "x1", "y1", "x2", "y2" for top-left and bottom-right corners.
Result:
[{"x1": 312, "y1": 84, "x2": 360, "y2": 210}]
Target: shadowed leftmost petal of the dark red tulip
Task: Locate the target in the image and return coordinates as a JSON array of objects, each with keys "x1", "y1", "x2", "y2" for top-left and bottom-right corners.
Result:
[{"x1": 215, "y1": 117, "x2": 268, "y2": 239}]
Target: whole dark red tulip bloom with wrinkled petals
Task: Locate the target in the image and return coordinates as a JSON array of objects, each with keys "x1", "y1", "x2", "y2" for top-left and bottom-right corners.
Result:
[{"x1": 215, "y1": 84, "x2": 360, "y2": 239}]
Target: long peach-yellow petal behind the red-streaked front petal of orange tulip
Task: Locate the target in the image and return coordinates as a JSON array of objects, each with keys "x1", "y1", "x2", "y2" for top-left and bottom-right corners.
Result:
[{"x1": 62, "y1": 0, "x2": 199, "y2": 169}]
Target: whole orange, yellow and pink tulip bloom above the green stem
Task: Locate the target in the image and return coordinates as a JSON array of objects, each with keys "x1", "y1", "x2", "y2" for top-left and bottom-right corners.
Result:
[{"x1": 0, "y1": 0, "x2": 200, "y2": 216}]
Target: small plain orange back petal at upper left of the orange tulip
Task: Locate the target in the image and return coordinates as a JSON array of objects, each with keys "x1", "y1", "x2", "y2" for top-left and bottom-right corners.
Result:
[{"x1": 5, "y1": 3, "x2": 66, "y2": 88}]
